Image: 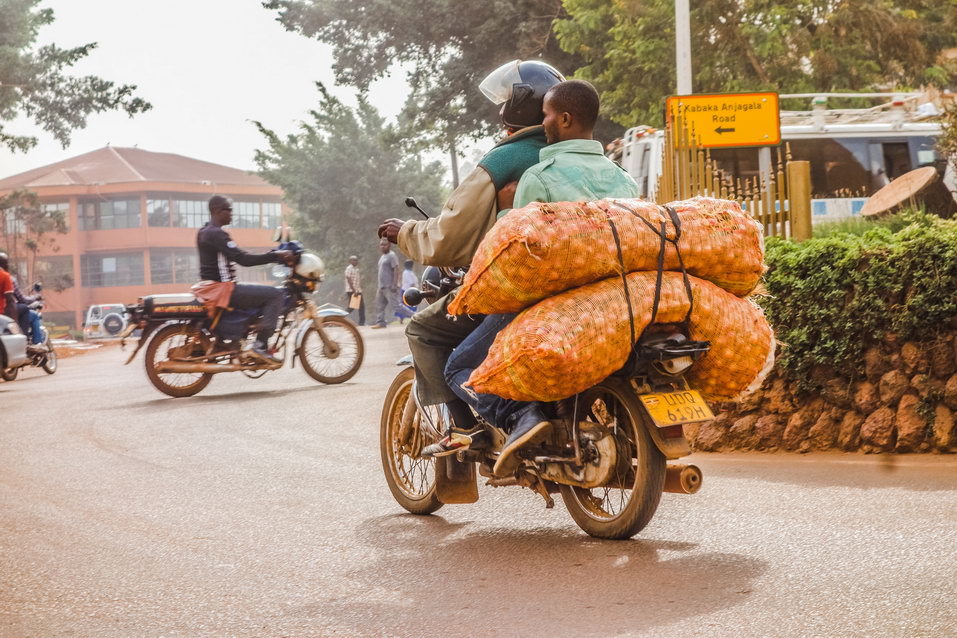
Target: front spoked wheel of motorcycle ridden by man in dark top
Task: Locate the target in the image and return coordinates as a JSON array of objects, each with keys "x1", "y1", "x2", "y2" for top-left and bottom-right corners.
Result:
[{"x1": 296, "y1": 317, "x2": 365, "y2": 383}]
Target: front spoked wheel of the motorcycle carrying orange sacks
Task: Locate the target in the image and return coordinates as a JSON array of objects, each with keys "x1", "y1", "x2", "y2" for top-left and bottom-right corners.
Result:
[{"x1": 379, "y1": 368, "x2": 442, "y2": 514}]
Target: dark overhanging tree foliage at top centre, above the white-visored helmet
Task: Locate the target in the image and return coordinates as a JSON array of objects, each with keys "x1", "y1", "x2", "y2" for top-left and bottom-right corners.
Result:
[{"x1": 263, "y1": 0, "x2": 576, "y2": 150}]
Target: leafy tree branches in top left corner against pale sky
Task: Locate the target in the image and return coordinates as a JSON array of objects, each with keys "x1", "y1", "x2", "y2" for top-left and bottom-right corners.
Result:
[{"x1": 0, "y1": 0, "x2": 151, "y2": 151}]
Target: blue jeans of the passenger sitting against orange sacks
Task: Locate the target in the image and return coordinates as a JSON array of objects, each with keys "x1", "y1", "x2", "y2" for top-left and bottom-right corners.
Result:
[{"x1": 445, "y1": 313, "x2": 542, "y2": 427}]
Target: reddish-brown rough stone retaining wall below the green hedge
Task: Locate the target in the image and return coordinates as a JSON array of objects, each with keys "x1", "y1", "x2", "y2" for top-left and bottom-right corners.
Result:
[{"x1": 686, "y1": 330, "x2": 957, "y2": 453}]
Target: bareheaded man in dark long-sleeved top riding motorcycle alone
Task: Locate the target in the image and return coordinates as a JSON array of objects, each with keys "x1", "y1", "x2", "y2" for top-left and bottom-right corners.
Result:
[{"x1": 196, "y1": 195, "x2": 292, "y2": 364}]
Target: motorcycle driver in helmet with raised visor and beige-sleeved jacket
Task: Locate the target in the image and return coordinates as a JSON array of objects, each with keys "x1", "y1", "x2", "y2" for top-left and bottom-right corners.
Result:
[{"x1": 378, "y1": 60, "x2": 565, "y2": 444}]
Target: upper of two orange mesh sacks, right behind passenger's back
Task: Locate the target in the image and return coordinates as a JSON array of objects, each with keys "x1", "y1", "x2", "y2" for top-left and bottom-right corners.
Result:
[{"x1": 449, "y1": 197, "x2": 764, "y2": 314}]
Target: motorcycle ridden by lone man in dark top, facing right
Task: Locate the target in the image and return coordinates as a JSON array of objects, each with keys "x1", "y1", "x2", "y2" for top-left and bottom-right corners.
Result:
[{"x1": 121, "y1": 242, "x2": 364, "y2": 397}]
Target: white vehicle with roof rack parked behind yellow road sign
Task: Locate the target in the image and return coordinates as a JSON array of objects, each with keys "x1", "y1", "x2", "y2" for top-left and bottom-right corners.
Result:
[{"x1": 612, "y1": 93, "x2": 957, "y2": 223}]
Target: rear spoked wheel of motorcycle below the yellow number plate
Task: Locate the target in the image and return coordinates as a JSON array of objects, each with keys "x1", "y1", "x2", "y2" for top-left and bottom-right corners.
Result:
[{"x1": 561, "y1": 379, "x2": 665, "y2": 539}]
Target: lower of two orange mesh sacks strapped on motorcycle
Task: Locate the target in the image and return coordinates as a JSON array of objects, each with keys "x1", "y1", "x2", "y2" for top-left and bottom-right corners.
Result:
[{"x1": 467, "y1": 272, "x2": 774, "y2": 401}]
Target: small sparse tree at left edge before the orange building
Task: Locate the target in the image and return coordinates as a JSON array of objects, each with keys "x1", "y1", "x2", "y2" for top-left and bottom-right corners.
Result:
[{"x1": 0, "y1": 190, "x2": 73, "y2": 291}]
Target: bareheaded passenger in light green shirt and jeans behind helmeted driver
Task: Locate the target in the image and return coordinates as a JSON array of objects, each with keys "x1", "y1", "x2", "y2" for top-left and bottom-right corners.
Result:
[{"x1": 423, "y1": 80, "x2": 638, "y2": 476}]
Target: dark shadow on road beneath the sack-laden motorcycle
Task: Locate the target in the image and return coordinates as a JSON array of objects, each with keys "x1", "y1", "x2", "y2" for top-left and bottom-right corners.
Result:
[{"x1": 290, "y1": 514, "x2": 767, "y2": 636}]
